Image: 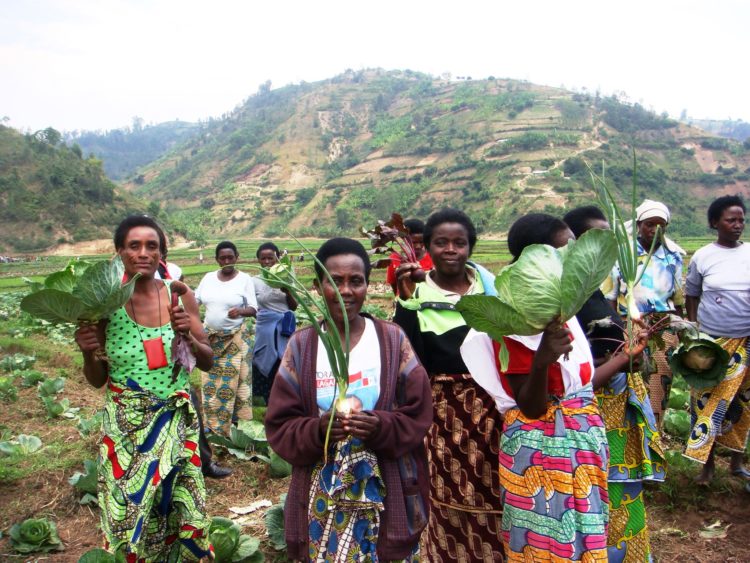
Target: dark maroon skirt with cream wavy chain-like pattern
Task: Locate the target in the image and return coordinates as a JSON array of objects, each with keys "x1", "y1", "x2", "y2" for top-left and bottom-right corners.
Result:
[{"x1": 423, "y1": 374, "x2": 503, "y2": 563}]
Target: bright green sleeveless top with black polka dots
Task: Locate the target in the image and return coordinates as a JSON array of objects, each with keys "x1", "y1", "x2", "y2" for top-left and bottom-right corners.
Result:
[{"x1": 105, "y1": 284, "x2": 188, "y2": 399}]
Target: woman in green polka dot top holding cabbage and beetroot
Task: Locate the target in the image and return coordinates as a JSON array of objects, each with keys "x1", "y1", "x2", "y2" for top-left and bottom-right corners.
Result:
[{"x1": 76, "y1": 215, "x2": 212, "y2": 561}]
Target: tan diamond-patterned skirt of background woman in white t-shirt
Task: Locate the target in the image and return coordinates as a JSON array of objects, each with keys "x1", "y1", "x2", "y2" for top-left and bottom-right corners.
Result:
[{"x1": 202, "y1": 324, "x2": 253, "y2": 436}]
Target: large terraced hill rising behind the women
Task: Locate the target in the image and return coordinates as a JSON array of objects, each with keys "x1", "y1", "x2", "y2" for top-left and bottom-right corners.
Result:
[{"x1": 125, "y1": 70, "x2": 750, "y2": 241}]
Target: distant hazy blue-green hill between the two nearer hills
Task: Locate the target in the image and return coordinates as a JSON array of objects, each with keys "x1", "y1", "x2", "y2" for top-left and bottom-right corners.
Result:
[{"x1": 65, "y1": 118, "x2": 200, "y2": 180}]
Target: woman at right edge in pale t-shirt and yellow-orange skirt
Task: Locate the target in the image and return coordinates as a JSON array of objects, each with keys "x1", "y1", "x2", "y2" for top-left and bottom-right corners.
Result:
[{"x1": 685, "y1": 196, "x2": 750, "y2": 484}]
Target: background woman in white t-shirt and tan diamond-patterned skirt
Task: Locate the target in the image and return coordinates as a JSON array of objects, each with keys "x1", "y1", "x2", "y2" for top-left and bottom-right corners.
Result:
[{"x1": 195, "y1": 241, "x2": 258, "y2": 436}]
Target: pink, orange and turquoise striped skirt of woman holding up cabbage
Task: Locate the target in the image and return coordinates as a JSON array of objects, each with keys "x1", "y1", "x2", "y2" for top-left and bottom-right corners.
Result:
[{"x1": 500, "y1": 385, "x2": 609, "y2": 561}]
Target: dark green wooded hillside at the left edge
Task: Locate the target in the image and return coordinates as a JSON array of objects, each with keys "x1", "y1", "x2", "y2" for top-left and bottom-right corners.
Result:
[{"x1": 0, "y1": 126, "x2": 143, "y2": 253}]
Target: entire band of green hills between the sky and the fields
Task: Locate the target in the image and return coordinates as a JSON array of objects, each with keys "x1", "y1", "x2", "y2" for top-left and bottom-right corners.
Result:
[{"x1": 0, "y1": 69, "x2": 750, "y2": 252}]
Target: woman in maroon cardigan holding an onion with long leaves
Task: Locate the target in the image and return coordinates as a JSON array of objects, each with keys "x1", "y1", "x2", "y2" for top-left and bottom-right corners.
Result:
[{"x1": 265, "y1": 238, "x2": 432, "y2": 561}]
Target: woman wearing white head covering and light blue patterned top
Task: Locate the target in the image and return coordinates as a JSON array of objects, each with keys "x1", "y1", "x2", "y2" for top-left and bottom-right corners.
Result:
[{"x1": 602, "y1": 199, "x2": 685, "y2": 426}]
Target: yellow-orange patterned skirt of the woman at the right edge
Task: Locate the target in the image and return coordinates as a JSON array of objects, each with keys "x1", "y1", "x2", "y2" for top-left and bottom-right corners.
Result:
[{"x1": 685, "y1": 337, "x2": 750, "y2": 463}]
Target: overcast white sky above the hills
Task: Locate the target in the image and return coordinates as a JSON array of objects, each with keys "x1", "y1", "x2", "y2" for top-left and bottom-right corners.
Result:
[{"x1": 0, "y1": 0, "x2": 750, "y2": 130}]
